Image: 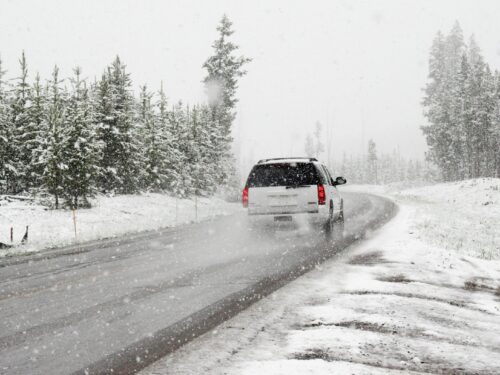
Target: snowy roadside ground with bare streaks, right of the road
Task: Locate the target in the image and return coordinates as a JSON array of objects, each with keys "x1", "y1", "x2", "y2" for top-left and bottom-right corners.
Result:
[{"x1": 144, "y1": 179, "x2": 500, "y2": 374}]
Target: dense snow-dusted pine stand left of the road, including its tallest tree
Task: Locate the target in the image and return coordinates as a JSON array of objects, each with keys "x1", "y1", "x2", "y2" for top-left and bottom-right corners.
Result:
[{"x1": 0, "y1": 16, "x2": 250, "y2": 208}]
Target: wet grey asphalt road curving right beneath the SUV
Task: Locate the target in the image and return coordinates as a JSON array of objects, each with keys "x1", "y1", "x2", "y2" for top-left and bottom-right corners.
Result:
[{"x1": 0, "y1": 193, "x2": 395, "y2": 374}]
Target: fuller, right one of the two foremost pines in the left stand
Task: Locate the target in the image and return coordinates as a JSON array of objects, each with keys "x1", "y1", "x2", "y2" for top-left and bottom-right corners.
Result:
[{"x1": 62, "y1": 67, "x2": 100, "y2": 209}]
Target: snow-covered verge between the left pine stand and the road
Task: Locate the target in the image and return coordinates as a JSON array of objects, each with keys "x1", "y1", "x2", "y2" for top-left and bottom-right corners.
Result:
[{"x1": 0, "y1": 193, "x2": 241, "y2": 257}]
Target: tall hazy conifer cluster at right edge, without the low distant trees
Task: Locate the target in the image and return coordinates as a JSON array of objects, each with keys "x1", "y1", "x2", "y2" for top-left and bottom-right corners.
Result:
[{"x1": 422, "y1": 22, "x2": 500, "y2": 181}]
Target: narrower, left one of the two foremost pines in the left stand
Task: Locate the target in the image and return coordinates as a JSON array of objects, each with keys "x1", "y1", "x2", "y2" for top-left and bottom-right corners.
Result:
[{"x1": 40, "y1": 66, "x2": 68, "y2": 209}]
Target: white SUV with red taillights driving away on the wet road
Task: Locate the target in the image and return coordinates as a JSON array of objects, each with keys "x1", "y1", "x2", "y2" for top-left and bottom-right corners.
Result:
[{"x1": 242, "y1": 158, "x2": 346, "y2": 236}]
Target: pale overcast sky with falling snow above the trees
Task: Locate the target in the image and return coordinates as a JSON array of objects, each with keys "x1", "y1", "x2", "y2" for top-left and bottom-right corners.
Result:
[{"x1": 0, "y1": 0, "x2": 500, "y2": 173}]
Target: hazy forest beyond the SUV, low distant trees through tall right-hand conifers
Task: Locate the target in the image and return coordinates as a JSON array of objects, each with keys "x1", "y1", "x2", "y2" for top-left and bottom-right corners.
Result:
[{"x1": 305, "y1": 22, "x2": 500, "y2": 184}]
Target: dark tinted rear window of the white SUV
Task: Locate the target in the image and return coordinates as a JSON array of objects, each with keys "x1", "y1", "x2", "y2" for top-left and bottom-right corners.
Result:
[{"x1": 247, "y1": 163, "x2": 318, "y2": 187}]
